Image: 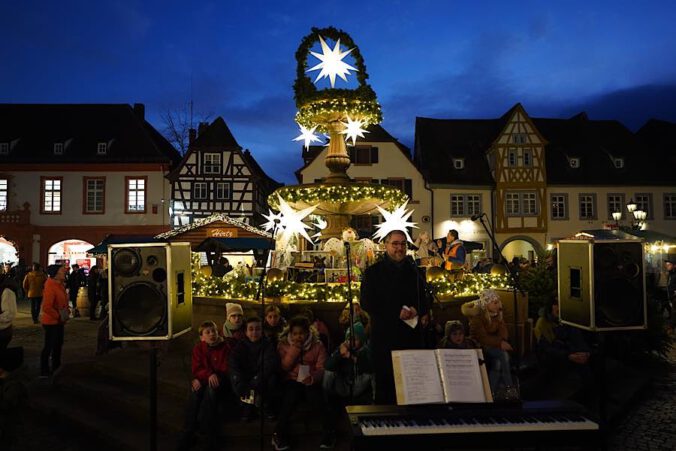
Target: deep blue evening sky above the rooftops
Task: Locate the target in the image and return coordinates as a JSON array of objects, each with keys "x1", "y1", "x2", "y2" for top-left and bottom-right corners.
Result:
[{"x1": 0, "y1": 0, "x2": 676, "y2": 183}]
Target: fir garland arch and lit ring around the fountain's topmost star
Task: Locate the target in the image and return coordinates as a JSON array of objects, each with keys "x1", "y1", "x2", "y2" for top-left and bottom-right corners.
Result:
[{"x1": 293, "y1": 27, "x2": 383, "y2": 133}]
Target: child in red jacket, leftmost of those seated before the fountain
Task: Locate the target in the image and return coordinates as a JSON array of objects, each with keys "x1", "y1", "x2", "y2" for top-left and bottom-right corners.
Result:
[{"x1": 178, "y1": 321, "x2": 233, "y2": 450}]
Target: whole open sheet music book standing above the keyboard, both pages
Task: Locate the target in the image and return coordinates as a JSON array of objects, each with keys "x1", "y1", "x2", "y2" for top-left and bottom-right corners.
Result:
[{"x1": 392, "y1": 349, "x2": 493, "y2": 405}]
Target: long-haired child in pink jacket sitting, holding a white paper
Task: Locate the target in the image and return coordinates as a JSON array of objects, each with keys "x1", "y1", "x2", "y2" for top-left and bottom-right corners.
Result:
[{"x1": 272, "y1": 316, "x2": 335, "y2": 451}]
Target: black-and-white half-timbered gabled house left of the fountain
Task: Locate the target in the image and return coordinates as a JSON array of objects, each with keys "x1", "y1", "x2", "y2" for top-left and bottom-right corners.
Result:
[{"x1": 170, "y1": 117, "x2": 281, "y2": 226}]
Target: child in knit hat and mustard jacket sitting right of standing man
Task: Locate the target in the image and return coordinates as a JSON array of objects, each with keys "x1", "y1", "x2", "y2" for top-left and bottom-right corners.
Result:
[{"x1": 461, "y1": 289, "x2": 518, "y2": 399}]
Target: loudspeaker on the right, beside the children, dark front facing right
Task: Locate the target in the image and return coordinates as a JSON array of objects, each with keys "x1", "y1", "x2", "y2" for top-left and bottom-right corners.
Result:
[{"x1": 558, "y1": 239, "x2": 647, "y2": 331}]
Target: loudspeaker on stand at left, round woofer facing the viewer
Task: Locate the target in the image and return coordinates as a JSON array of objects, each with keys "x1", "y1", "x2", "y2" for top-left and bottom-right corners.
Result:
[{"x1": 108, "y1": 243, "x2": 192, "y2": 341}]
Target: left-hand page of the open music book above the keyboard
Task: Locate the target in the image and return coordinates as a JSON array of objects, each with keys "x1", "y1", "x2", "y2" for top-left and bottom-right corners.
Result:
[{"x1": 392, "y1": 350, "x2": 444, "y2": 404}]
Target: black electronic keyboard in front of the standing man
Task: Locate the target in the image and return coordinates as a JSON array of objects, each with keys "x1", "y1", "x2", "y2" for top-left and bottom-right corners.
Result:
[{"x1": 347, "y1": 401, "x2": 602, "y2": 451}]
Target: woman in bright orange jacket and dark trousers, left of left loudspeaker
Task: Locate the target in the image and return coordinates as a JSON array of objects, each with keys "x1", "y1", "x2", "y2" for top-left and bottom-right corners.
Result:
[{"x1": 40, "y1": 265, "x2": 70, "y2": 377}]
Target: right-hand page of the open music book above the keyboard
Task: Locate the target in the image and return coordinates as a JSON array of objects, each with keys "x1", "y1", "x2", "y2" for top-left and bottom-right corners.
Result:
[{"x1": 436, "y1": 349, "x2": 486, "y2": 402}]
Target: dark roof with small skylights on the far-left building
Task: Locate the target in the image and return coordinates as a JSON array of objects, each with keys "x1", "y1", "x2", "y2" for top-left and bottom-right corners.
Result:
[{"x1": 0, "y1": 104, "x2": 180, "y2": 165}]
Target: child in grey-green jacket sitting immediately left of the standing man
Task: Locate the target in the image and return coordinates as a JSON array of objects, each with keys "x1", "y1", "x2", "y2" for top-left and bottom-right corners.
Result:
[{"x1": 322, "y1": 323, "x2": 373, "y2": 408}]
